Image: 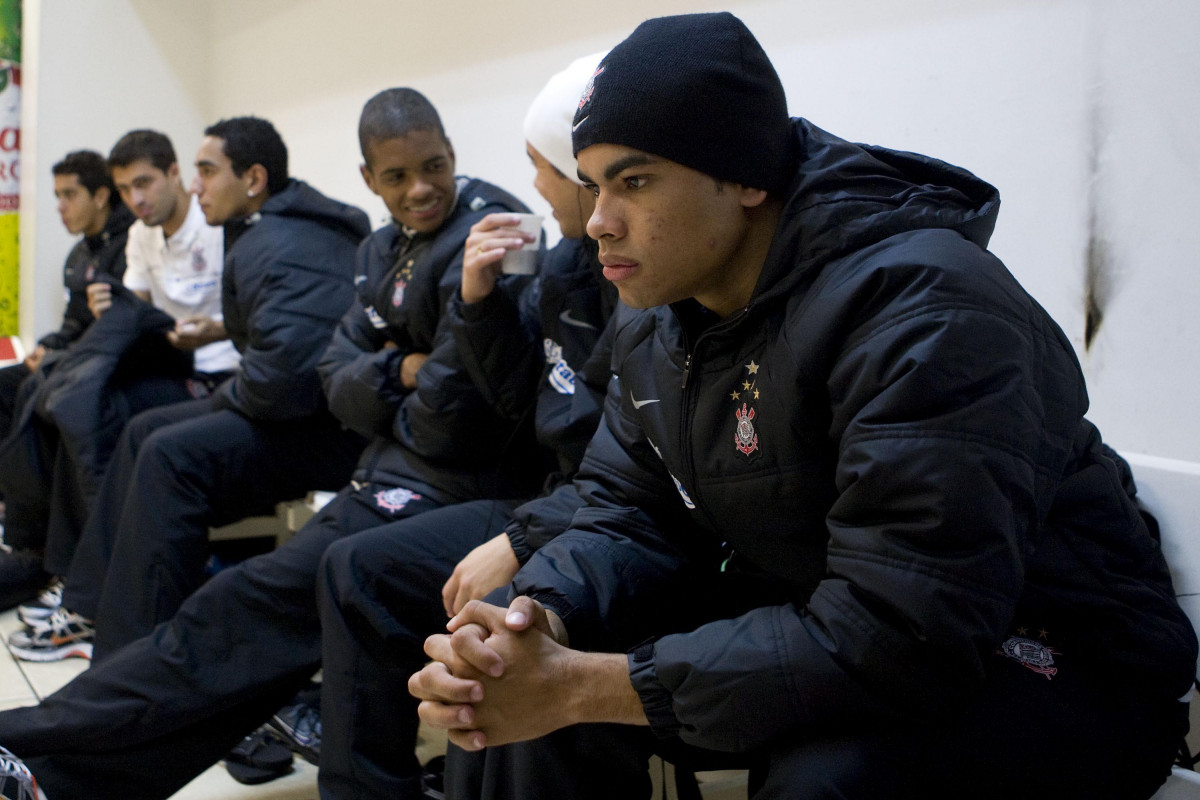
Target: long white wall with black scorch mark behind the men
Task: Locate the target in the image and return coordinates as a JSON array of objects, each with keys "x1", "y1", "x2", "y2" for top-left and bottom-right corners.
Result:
[{"x1": 18, "y1": 0, "x2": 1200, "y2": 474}]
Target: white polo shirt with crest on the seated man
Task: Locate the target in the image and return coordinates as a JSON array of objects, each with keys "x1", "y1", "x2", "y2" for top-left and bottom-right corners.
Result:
[{"x1": 121, "y1": 196, "x2": 241, "y2": 372}]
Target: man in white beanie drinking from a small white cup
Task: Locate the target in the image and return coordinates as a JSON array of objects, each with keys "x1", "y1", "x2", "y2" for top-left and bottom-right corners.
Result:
[{"x1": 319, "y1": 54, "x2": 650, "y2": 800}]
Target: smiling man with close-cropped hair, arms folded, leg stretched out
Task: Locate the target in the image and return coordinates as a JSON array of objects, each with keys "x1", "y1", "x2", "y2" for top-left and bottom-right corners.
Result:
[{"x1": 0, "y1": 89, "x2": 545, "y2": 800}]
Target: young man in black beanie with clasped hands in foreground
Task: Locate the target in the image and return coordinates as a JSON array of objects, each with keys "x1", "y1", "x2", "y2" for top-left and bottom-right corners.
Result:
[{"x1": 409, "y1": 13, "x2": 1196, "y2": 799}]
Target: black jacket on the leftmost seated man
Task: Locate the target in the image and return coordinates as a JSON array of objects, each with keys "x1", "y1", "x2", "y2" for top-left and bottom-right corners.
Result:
[{"x1": 37, "y1": 203, "x2": 133, "y2": 350}]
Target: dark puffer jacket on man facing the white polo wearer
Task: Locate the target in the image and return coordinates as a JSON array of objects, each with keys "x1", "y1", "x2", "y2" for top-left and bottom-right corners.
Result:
[{"x1": 212, "y1": 180, "x2": 371, "y2": 421}]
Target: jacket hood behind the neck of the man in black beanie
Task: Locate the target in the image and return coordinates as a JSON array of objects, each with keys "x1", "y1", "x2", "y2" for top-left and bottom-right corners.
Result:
[{"x1": 755, "y1": 118, "x2": 1000, "y2": 307}]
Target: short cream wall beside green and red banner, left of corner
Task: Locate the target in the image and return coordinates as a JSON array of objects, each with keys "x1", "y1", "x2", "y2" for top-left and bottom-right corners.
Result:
[{"x1": 20, "y1": 0, "x2": 211, "y2": 342}]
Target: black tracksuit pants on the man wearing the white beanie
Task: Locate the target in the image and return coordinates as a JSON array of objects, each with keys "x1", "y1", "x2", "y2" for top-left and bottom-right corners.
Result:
[{"x1": 319, "y1": 500, "x2": 528, "y2": 800}]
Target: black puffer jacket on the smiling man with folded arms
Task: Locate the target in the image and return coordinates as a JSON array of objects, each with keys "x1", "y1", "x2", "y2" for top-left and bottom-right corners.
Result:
[{"x1": 320, "y1": 178, "x2": 545, "y2": 503}]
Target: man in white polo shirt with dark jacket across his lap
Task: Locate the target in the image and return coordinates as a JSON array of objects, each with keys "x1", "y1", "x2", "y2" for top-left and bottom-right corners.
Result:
[{"x1": 0, "y1": 131, "x2": 238, "y2": 619}]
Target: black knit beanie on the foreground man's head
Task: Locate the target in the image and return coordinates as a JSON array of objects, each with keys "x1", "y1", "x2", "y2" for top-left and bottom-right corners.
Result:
[{"x1": 572, "y1": 12, "x2": 793, "y2": 190}]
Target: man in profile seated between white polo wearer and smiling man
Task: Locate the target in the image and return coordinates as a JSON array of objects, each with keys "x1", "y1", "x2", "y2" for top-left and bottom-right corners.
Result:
[{"x1": 10, "y1": 118, "x2": 370, "y2": 661}]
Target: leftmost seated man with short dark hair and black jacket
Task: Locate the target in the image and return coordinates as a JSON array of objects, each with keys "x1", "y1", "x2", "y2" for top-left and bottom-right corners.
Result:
[{"x1": 0, "y1": 150, "x2": 133, "y2": 608}]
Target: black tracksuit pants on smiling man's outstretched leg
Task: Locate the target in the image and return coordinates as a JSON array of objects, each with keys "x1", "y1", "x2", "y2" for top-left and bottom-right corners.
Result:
[{"x1": 0, "y1": 485, "x2": 444, "y2": 800}]
